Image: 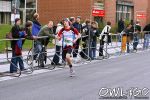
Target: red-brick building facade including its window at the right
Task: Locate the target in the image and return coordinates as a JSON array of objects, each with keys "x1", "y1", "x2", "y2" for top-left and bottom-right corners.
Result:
[{"x1": 37, "y1": 0, "x2": 150, "y2": 26}]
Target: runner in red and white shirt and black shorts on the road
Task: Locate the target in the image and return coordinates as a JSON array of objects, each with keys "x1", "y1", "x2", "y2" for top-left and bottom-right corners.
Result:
[{"x1": 57, "y1": 19, "x2": 80, "y2": 77}]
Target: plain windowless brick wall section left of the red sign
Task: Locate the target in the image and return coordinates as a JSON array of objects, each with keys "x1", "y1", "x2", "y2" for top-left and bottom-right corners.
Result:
[{"x1": 37, "y1": 0, "x2": 93, "y2": 24}]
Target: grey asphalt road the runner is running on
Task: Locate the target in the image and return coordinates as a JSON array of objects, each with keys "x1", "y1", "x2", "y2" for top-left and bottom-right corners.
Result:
[{"x1": 0, "y1": 51, "x2": 150, "y2": 100}]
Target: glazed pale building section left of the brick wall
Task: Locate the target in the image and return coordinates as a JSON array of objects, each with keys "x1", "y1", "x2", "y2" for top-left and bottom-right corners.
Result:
[{"x1": 0, "y1": 0, "x2": 37, "y2": 24}]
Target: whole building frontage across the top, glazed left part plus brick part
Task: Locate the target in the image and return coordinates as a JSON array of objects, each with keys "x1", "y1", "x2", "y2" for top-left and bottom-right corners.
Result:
[{"x1": 0, "y1": 0, "x2": 150, "y2": 26}]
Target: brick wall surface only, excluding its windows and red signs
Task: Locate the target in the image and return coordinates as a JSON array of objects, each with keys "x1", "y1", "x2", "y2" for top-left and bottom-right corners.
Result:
[{"x1": 37, "y1": 0, "x2": 150, "y2": 26}]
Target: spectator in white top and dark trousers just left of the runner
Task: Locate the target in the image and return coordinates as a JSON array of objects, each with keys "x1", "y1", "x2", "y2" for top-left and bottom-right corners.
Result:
[{"x1": 51, "y1": 22, "x2": 64, "y2": 65}]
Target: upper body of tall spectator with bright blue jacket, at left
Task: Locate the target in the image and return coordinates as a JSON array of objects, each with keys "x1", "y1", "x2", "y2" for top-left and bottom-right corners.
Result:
[{"x1": 32, "y1": 13, "x2": 41, "y2": 36}]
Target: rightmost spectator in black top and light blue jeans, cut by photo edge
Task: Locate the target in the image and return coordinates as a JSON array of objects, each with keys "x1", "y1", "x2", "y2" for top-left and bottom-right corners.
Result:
[{"x1": 143, "y1": 24, "x2": 150, "y2": 49}]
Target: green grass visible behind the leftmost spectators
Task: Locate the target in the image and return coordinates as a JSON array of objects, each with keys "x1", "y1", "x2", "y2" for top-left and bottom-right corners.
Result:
[{"x1": 0, "y1": 25, "x2": 54, "y2": 53}]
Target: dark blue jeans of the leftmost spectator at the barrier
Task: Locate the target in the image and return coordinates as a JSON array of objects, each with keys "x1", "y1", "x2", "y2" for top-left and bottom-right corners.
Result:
[{"x1": 10, "y1": 51, "x2": 24, "y2": 73}]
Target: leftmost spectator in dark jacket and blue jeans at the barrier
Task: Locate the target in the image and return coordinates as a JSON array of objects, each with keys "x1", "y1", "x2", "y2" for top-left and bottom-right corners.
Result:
[{"x1": 10, "y1": 18, "x2": 25, "y2": 73}]
